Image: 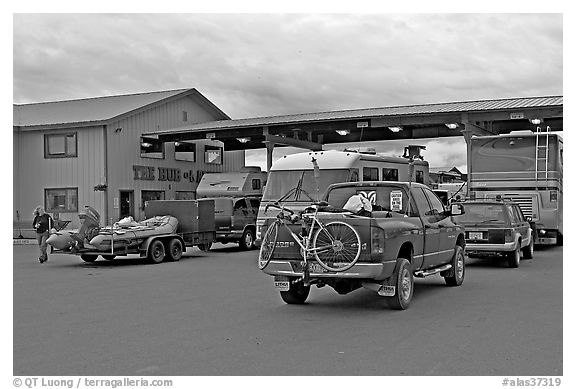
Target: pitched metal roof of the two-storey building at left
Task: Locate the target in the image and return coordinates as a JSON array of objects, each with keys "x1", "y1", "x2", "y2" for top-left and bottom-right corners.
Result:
[{"x1": 13, "y1": 88, "x2": 229, "y2": 127}]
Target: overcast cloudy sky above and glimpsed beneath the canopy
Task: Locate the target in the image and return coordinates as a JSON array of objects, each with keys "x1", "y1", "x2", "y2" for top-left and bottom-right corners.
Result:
[{"x1": 13, "y1": 13, "x2": 563, "y2": 171}]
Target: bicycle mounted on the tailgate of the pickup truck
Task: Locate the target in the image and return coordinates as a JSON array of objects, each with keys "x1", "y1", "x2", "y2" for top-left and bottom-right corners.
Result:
[{"x1": 258, "y1": 200, "x2": 361, "y2": 276}]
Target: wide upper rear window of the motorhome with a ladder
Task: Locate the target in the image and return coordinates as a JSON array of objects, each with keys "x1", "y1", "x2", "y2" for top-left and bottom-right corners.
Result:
[{"x1": 471, "y1": 135, "x2": 558, "y2": 173}]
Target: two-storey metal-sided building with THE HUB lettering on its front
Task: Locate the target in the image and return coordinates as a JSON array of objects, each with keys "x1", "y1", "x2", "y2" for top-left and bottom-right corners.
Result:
[{"x1": 13, "y1": 89, "x2": 244, "y2": 236}]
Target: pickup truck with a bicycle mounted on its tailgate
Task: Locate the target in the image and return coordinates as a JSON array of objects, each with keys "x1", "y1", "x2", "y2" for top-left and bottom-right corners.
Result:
[{"x1": 259, "y1": 181, "x2": 466, "y2": 309}]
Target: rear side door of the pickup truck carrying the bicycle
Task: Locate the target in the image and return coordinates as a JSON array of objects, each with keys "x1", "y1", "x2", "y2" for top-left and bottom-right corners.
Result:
[{"x1": 412, "y1": 188, "x2": 440, "y2": 269}]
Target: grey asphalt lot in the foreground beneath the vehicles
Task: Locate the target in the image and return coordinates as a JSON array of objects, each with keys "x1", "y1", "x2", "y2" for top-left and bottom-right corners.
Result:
[{"x1": 13, "y1": 244, "x2": 563, "y2": 376}]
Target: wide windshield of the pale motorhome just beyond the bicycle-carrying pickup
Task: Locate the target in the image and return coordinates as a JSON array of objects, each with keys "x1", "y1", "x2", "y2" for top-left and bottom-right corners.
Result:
[{"x1": 262, "y1": 169, "x2": 350, "y2": 203}]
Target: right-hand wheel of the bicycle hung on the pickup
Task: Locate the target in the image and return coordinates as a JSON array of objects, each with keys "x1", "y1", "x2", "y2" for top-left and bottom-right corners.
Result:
[{"x1": 312, "y1": 221, "x2": 360, "y2": 272}]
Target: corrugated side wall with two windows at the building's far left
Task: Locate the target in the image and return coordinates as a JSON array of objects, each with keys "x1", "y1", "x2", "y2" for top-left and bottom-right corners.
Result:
[{"x1": 13, "y1": 127, "x2": 104, "y2": 227}]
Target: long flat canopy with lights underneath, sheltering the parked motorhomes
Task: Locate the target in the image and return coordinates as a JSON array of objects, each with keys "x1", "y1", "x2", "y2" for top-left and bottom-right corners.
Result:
[{"x1": 145, "y1": 96, "x2": 563, "y2": 151}]
